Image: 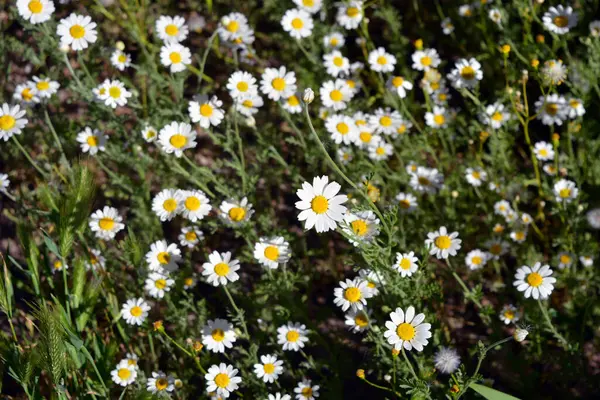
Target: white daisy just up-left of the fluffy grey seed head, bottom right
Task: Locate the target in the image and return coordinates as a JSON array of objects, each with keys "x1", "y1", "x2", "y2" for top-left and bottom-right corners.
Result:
[{"x1": 383, "y1": 306, "x2": 431, "y2": 351}]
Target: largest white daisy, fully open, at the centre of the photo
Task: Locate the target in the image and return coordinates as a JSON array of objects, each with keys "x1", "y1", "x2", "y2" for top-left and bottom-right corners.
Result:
[{"x1": 296, "y1": 176, "x2": 348, "y2": 233}]
